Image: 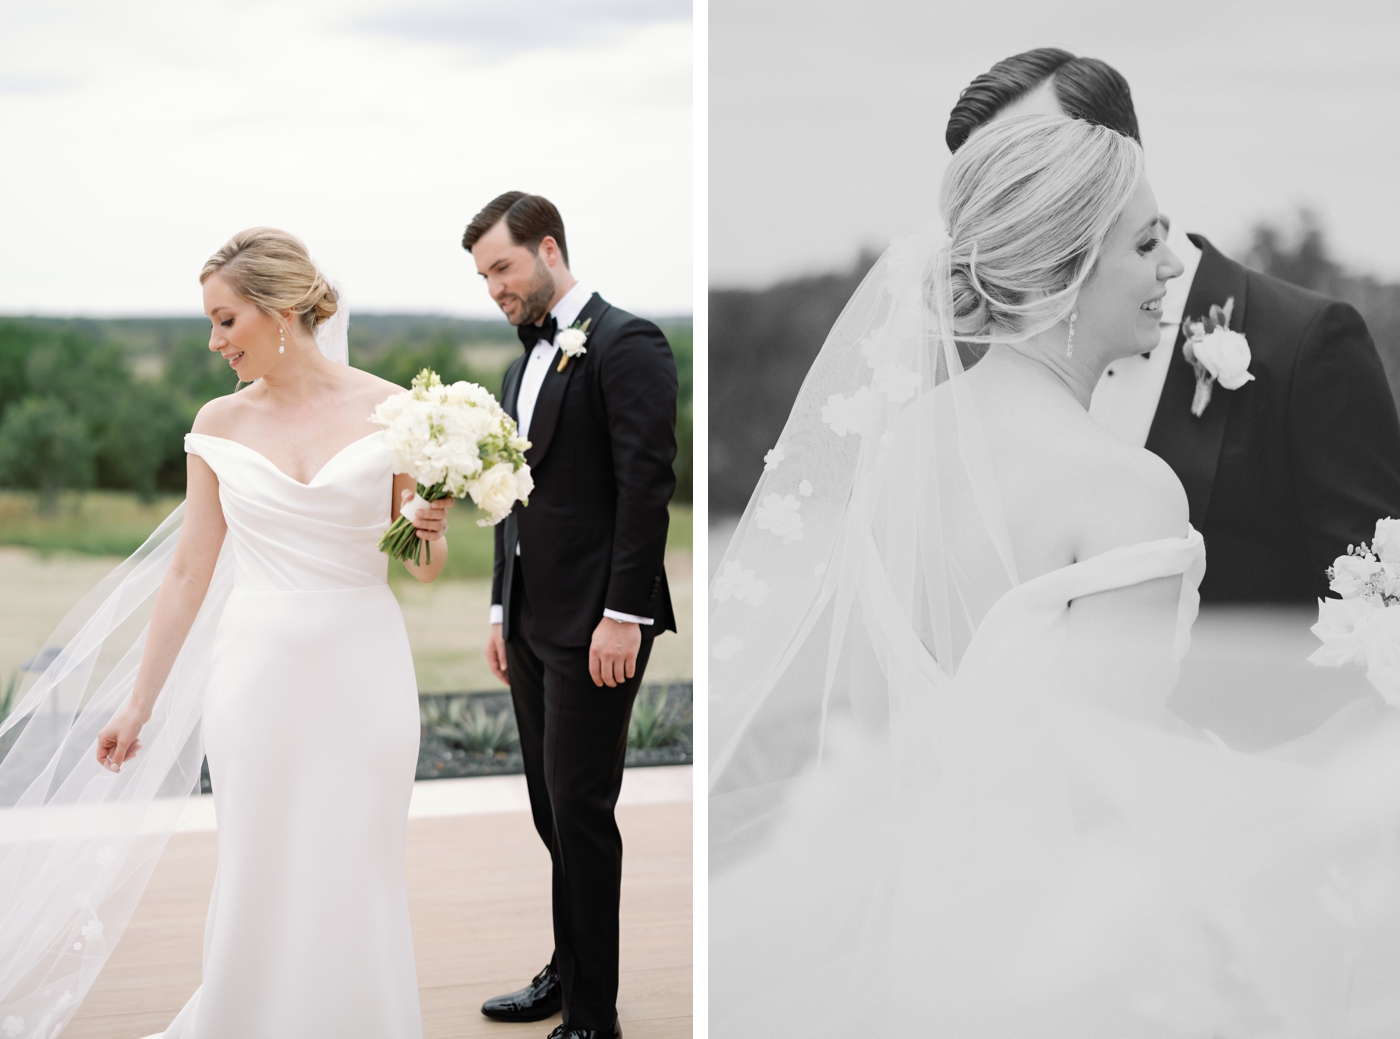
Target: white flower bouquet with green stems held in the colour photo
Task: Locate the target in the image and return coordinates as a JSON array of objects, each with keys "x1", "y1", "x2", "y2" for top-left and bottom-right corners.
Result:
[{"x1": 370, "y1": 368, "x2": 535, "y2": 564}]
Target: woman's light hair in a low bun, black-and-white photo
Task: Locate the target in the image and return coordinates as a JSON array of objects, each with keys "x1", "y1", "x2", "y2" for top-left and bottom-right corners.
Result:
[{"x1": 939, "y1": 115, "x2": 1142, "y2": 343}]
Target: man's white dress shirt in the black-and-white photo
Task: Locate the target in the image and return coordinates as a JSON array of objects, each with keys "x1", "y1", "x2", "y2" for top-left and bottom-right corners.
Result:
[{"x1": 1089, "y1": 223, "x2": 1201, "y2": 447}]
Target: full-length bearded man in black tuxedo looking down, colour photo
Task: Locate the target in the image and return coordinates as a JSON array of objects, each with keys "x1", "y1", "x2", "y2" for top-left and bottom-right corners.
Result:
[{"x1": 462, "y1": 192, "x2": 676, "y2": 1039}]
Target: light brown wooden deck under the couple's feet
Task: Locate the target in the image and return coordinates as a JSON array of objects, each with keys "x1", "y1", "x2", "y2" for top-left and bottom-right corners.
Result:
[{"x1": 63, "y1": 789, "x2": 692, "y2": 1039}]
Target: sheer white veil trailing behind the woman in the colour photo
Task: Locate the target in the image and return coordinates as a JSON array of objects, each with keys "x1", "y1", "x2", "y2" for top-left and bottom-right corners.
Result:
[{"x1": 0, "y1": 284, "x2": 349, "y2": 1038}]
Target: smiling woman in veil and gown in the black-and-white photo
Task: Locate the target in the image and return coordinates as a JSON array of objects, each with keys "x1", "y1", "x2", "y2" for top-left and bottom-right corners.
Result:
[{"x1": 710, "y1": 116, "x2": 1400, "y2": 1039}]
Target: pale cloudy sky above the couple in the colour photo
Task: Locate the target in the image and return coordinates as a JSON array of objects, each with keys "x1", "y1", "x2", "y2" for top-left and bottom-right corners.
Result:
[{"x1": 0, "y1": 0, "x2": 693, "y2": 315}]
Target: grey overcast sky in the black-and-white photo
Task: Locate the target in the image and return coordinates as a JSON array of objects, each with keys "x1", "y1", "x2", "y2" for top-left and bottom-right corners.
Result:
[{"x1": 708, "y1": 0, "x2": 1400, "y2": 286}]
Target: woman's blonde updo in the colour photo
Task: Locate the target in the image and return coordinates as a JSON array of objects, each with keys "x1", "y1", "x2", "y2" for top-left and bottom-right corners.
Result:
[{"x1": 199, "y1": 227, "x2": 340, "y2": 332}]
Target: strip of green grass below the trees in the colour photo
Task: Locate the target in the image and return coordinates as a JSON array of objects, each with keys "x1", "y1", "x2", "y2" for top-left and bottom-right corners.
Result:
[{"x1": 0, "y1": 490, "x2": 694, "y2": 583}]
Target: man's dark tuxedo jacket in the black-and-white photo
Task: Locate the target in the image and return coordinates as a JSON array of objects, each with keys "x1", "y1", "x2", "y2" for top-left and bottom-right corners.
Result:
[{"x1": 1147, "y1": 235, "x2": 1400, "y2": 602}]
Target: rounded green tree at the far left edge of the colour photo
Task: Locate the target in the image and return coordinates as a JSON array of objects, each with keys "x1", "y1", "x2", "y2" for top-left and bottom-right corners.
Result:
[{"x1": 0, "y1": 396, "x2": 94, "y2": 508}]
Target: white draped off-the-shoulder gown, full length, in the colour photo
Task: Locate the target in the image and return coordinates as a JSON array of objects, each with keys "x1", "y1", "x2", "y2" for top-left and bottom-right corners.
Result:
[{"x1": 156, "y1": 433, "x2": 421, "y2": 1039}]
